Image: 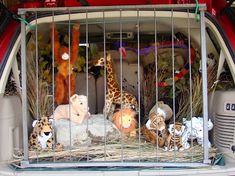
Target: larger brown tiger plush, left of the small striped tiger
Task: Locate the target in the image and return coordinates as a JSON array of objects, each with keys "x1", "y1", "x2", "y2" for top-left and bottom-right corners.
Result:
[{"x1": 141, "y1": 108, "x2": 168, "y2": 147}]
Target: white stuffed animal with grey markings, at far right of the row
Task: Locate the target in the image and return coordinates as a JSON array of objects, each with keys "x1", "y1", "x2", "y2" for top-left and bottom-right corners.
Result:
[{"x1": 182, "y1": 117, "x2": 213, "y2": 149}]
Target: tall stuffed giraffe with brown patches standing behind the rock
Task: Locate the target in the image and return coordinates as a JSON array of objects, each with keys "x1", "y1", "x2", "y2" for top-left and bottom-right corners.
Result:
[{"x1": 94, "y1": 54, "x2": 138, "y2": 119}]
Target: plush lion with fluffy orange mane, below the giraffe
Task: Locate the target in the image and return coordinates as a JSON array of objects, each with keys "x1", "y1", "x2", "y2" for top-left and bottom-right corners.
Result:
[{"x1": 112, "y1": 108, "x2": 137, "y2": 137}]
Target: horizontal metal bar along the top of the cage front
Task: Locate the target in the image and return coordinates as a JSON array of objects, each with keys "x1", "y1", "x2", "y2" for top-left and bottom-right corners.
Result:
[{"x1": 18, "y1": 4, "x2": 206, "y2": 15}]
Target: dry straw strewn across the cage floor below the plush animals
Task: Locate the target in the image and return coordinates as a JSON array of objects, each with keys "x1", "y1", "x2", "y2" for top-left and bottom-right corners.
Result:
[{"x1": 14, "y1": 139, "x2": 217, "y2": 163}]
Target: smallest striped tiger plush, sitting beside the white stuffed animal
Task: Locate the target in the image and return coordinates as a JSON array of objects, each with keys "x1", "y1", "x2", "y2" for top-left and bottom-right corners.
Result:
[{"x1": 165, "y1": 122, "x2": 185, "y2": 151}]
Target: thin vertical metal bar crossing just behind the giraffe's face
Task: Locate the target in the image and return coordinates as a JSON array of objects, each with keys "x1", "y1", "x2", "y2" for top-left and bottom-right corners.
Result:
[{"x1": 103, "y1": 11, "x2": 107, "y2": 161}]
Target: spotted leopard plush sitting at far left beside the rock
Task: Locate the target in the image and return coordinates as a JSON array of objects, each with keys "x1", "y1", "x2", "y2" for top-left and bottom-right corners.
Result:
[{"x1": 29, "y1": 117, "x2": 63, "y2": 150}]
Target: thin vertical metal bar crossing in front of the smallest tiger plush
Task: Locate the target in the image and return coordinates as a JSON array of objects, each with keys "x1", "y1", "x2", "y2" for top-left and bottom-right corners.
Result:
[{"x1": 171, "y1": 9, "x2": 176, "y2": 161}]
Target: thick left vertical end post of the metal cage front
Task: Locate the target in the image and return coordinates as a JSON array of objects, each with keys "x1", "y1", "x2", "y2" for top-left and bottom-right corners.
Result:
[{"x1": 21, "y1": 15, "x2": 29, "y2": 164}]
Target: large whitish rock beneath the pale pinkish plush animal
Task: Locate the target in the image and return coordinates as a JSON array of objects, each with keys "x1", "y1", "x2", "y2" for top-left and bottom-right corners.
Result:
[{"x1": 55, "y1": 114, "x2": 120, "y2": 147}]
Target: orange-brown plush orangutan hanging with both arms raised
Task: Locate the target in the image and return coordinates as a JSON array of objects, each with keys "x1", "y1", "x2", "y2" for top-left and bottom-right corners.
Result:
[{"x1": 50, "y1": 24, "x2": 80, "y2": 105}]
